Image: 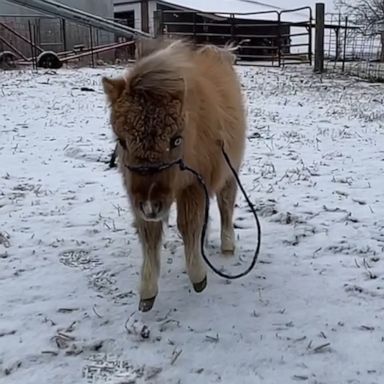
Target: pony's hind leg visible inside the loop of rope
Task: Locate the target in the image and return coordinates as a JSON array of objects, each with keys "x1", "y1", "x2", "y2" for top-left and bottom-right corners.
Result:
[{"x1": 217, "y1": 177, "x2": 237, "y2": 255}]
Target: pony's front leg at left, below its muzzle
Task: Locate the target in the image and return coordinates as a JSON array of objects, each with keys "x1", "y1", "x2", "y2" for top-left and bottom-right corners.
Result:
[{"x1": 136, "y1": 218, "x2": 162, "y2": 312}]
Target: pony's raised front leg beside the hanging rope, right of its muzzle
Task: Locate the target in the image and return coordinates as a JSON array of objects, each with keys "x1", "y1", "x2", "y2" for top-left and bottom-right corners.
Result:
[{"x1": 177, "y1": 186, "x2": 207, "y2": 292}]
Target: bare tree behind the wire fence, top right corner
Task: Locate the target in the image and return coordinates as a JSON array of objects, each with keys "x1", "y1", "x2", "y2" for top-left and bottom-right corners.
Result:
[{"x1": 335, "y1": 0, "x2": 384, "y2": 61}]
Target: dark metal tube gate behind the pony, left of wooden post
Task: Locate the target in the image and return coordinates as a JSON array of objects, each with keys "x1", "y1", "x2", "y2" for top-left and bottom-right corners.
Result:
[{"x1": 155, "y1": 7, "x2": 312, "y2": 66}]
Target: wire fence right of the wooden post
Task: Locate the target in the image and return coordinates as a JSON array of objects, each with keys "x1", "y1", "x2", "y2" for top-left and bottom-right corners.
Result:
[{"x1": 324, "y1": 14, "x2": 384, "y2": 81}]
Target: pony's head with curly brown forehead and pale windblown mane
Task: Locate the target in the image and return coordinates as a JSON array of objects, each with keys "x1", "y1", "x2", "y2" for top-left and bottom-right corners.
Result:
[{"x1": 103, "y1": 41, "x2": 191, "y2": 221}]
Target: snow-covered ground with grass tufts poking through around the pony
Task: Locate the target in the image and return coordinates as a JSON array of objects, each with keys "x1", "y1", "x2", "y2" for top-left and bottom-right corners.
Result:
[{"x1": 0, "y1": 63, "x2": 384, "y2": 384}]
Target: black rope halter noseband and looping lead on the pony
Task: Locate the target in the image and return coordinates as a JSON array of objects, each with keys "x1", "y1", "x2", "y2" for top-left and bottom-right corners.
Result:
[{"x1": 127, "y1": 146, "x2": 261, "y2": 280}]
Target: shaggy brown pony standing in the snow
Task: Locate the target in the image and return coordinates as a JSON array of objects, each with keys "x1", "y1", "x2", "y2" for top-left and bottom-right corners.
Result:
[{"x1": 102, "y1": 40, "x2": 246, "y2": 311}]
